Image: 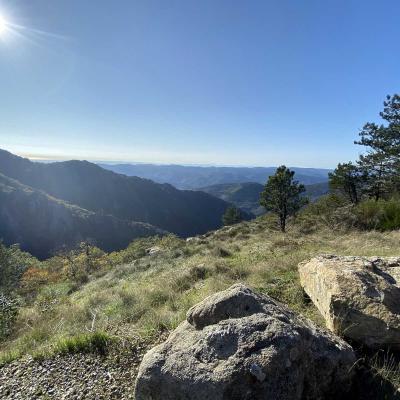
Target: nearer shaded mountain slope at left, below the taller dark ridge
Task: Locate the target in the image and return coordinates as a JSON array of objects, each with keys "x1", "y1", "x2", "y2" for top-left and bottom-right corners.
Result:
[{"x1": 0, "y1": 174, "x2": 165, "y2": 259}]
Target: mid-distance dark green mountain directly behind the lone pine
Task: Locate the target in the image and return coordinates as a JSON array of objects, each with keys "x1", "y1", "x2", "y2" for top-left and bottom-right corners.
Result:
[{"x1": 198, "y1": 182, "x2": 329, "y2": 215}]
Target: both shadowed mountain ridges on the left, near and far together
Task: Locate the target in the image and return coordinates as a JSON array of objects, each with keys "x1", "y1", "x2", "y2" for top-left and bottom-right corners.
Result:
[{"x1": 0, "y1": 150, "x2": 234, "y2": 257}]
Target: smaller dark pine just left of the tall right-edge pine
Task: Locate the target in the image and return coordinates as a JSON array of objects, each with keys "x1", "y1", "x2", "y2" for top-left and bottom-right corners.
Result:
[{"x1": 329, "y1": 162, "x2": 365, "y2": 204}]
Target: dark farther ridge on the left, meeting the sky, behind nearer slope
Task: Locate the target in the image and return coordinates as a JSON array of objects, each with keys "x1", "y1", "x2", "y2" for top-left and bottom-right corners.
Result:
[{"x1": 0, "y1": 150, "x2": 228, "y2": 236}]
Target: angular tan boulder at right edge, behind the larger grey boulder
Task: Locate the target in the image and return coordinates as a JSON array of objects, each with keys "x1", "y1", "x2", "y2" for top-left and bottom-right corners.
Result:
[{"x1": 299, "y1": 255, "x2": 400, "y2": 349}]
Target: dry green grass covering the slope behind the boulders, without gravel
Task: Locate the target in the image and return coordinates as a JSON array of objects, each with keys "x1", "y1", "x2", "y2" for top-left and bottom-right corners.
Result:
[{"x1": 0, "y1": 217, "x2": 400, "y2": 376}]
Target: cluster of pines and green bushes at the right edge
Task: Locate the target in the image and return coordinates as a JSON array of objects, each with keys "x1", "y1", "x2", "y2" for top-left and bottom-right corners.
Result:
[{"x1": 325, "y1": 94, "x2": 400, "y2": 231}]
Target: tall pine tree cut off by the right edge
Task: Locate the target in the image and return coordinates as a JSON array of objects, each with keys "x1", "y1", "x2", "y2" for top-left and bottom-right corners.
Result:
[{"x1": 354, "y1": 94, "x2": 400, "y2": 200}]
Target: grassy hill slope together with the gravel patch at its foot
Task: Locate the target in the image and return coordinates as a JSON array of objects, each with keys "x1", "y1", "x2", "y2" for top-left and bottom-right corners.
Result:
[{"x1": 0, "y1": 217, "x2": 400, "y2": 400}]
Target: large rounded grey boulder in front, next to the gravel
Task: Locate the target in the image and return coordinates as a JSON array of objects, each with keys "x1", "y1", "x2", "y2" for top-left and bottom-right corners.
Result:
[{"x1": 135, "y1": 284, "x2": 355, "y2": 400}]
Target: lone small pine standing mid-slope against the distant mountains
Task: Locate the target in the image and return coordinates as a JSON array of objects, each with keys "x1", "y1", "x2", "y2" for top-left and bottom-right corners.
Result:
[{"x1": 260, "y1": 165, "x2": 308, "y2": 232}]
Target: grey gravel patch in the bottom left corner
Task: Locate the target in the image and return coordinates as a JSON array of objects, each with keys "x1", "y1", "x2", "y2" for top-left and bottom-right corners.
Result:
[{"x1": 0, "y1": 338, "x2": 163, "y2": 400}]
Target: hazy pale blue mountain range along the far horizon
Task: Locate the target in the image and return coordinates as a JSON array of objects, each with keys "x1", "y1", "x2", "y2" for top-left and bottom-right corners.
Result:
[{"x1": 100, "y1": 163, "x2": 330, "y2": 189}]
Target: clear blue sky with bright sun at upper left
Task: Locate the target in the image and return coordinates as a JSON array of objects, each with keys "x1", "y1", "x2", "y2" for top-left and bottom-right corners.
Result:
[{"x1": 0, "y1": 0, "x2": 400, "y2": 168}]
